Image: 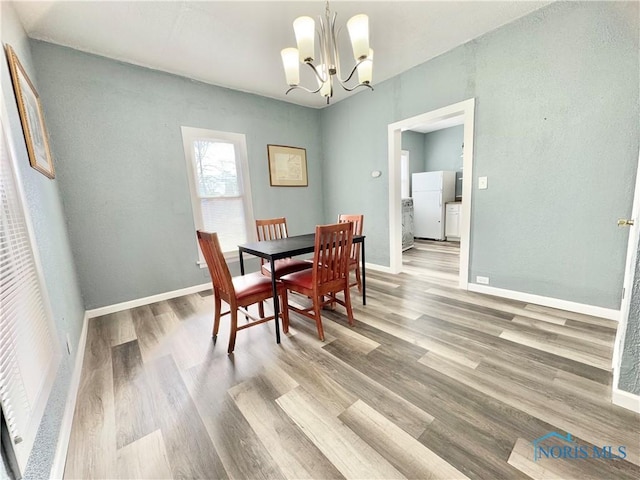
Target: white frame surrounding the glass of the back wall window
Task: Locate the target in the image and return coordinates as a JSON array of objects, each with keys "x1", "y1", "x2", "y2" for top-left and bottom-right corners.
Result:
[{"x1": 181, "y1": 126, "x2": 256, "y2": 268}]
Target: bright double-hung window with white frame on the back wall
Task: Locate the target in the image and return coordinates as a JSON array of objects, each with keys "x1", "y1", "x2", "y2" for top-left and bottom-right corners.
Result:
[{"x1": 182, "y1": 127, "x2": 255, "y2": 262}]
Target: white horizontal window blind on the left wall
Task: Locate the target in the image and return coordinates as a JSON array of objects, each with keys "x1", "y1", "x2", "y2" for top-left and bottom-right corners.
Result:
[{"x1": 0, "y1": 115, "x2": 59, "y2": 472}]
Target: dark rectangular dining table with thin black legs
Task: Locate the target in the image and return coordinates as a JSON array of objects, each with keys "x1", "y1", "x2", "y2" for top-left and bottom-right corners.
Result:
[{"x1": 238, "y1": 233, "x2": 367, "y2": 343}]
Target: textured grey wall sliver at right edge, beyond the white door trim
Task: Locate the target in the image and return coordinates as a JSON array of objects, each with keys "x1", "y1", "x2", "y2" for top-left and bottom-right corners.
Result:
[{"x1": 618, "y1": 234, "x2": 640, "y2": 395}]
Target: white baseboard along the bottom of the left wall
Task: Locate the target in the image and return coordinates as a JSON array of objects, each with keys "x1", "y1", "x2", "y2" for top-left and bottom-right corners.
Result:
[{"x1": 49, "y1": 312, "x2": 89, "y2": 479}]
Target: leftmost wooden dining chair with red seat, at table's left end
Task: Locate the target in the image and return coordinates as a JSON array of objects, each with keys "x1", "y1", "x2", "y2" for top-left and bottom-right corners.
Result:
[{"x1": 197, "y1": 230, "x2": 289, "y2": 353}]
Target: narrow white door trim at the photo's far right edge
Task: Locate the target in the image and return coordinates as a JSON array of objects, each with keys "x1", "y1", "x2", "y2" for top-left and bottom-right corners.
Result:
[{"x1": 611, "y1": 153, "x2": 640, "y2": 391}]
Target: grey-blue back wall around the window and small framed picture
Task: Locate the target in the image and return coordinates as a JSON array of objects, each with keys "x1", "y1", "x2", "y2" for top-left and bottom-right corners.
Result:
[{"x1": 32, "y1": 41, "x2": 323, "y2": 309}]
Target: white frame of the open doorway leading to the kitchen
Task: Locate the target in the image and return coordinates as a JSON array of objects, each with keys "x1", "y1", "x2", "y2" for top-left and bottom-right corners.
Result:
[{"x1": 388, "y1": 98, "x2": 475, "y2": 284}]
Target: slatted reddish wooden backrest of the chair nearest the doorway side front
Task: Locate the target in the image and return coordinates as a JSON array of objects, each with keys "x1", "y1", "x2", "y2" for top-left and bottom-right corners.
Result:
[{"x1": 312, "y1": 223, "x2": 353, "y2": 292}]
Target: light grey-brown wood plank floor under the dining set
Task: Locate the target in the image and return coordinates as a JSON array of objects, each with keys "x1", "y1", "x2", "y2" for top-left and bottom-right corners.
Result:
[{"x1": 65, "y1": 242, "x2": 640, "y2": 479}]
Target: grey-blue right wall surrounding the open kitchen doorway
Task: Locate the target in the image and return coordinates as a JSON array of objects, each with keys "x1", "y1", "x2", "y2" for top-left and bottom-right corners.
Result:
[{"x1": 321, "y1": 2, "x2": 639, "y2": 309}]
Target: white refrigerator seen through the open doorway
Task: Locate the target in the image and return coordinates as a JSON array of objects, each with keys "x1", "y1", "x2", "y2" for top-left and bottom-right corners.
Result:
[{"x1": 411, "y1": 171, "x2": 456, "y2": 240}]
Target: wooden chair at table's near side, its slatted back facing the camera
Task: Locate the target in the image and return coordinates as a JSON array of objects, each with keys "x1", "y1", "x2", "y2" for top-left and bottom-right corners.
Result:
[{"x1": 280, "y1": 223, "x2": 353, "y2": 340}]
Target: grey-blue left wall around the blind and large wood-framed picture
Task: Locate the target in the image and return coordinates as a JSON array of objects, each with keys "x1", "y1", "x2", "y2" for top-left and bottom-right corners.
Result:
[{"x1": 0, "y1": 2, "x2": 84, "y2": 478}]
